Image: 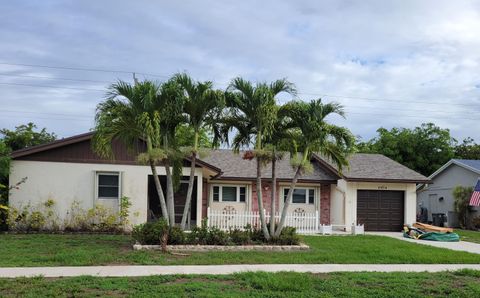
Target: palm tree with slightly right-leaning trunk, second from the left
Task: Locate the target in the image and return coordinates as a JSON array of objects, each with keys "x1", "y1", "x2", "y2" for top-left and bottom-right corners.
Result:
[{"x1": 174, "y1": 74, "x2": 224, "y2": 230}]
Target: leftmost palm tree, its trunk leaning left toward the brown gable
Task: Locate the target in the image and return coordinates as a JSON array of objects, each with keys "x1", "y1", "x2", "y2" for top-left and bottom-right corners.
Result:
[{"x1": 93, "y1": 81, "x2": 169, "y2": 223}]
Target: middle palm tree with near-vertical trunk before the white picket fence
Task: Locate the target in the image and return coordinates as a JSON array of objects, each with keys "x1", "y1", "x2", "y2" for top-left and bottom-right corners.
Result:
[{"x1": 225, "y1": 78, "x2": 295, "y2": 240}]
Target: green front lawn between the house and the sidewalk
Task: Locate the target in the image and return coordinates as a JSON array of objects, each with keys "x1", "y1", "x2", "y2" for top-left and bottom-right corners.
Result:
[{"x1": 0, "y1": 234, "x2": 480, "y2": 267}]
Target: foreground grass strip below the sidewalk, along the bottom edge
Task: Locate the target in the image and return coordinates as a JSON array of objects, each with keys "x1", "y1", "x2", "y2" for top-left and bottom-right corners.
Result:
[{"x1": 0, "y1": 270, "x2": 480, "y2": 297}]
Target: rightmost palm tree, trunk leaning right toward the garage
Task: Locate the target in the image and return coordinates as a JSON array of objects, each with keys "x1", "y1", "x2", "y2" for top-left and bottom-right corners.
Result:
[{"x1": 275, "y1": 99, "x2": 355, "y2": 237}]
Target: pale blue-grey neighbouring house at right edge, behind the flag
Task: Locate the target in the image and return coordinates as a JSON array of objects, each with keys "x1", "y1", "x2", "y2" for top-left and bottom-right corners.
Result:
[{"x1": 417, "y1": 159, "x2": 480, "y2": 227}]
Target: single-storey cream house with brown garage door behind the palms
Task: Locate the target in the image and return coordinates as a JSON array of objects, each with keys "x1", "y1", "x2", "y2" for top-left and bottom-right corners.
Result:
[{"x1": 6, "y1": 133, "x2": 429, "y2": 231}]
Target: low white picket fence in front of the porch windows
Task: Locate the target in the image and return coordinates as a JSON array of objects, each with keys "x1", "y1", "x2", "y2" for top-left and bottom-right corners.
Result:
[{"x1": 207, "y1": 207, "x2": 320, "y2": 234}]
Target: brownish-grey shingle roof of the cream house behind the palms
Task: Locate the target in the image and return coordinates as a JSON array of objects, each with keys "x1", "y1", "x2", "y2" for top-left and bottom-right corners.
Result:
[{"x1": 12, "y1": 132, "x2": 430, "y2": 183}]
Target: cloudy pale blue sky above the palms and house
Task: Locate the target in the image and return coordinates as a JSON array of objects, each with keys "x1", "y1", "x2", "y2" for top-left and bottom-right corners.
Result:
[{"x1": 0, "y1": 0, "x2": 480, "y2": 142}]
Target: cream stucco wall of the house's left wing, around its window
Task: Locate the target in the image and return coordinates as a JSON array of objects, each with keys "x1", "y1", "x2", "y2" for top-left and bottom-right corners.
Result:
[{"x1": 9, "y1": 160, "x2": 202, "y2": 224}]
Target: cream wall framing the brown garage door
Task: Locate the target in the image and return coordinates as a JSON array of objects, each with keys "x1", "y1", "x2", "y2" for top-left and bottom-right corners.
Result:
[{"x1": 337, "y1": 179, "x2": 417, "y2": 231}]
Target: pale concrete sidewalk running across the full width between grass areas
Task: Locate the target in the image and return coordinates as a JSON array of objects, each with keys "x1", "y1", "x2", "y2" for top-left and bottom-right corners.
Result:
[{"x1": 0, "y1": 264, "x2": 480, "y2": 278}]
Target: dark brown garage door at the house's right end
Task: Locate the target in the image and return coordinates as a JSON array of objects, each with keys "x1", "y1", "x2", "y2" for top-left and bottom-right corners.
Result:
[{"x1": 357, "y1": 190, "x2": 404, "y2": 231}]
